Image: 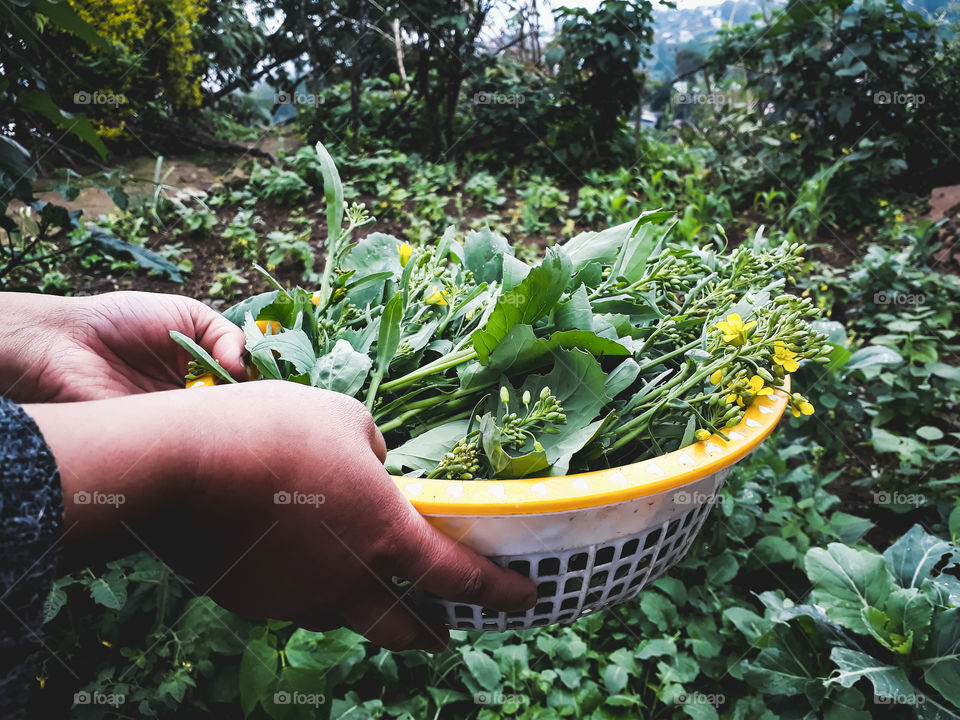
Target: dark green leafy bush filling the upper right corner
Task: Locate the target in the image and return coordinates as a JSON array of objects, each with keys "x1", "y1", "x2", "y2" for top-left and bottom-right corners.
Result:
[{"x1": 710, "y1": 0, "x2": 958, "y2": 208}]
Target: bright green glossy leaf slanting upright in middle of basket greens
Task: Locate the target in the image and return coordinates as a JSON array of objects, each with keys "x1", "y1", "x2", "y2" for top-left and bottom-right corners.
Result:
[{"x1": 471, "y1": 248, "x2": 570, "y2": 365}]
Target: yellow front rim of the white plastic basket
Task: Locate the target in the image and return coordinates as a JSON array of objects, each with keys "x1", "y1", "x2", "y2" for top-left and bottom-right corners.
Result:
[{"x1": 393, "y1": 378, "x2": 790, "y2": 515}]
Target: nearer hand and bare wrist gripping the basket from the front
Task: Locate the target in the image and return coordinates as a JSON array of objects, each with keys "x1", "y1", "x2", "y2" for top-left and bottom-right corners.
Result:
[{"x1": 27, "y1": 381, "x2": 536, "y2": 650}]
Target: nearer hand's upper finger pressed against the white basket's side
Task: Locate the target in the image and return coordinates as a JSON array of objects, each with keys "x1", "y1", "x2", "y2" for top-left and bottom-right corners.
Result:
[{"x1": 395, "y1": 513, "x2": 537, "y2": 611}]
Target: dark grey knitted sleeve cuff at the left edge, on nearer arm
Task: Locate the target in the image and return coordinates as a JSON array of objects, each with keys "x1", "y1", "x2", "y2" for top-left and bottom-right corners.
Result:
[{"x1": 0, "y1": 398, "x2": 63, "y2": 718}]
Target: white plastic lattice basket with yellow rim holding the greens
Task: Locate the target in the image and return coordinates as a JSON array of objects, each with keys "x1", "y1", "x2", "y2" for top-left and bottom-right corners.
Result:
[{"x1": 394, "y1": 378, "x2": 789, "y2": 632}]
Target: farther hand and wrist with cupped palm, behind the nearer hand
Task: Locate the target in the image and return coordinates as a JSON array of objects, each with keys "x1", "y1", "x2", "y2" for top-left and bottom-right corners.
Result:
[{"x1": 0, "y1": 292, "x2": 246, "y2": 402}]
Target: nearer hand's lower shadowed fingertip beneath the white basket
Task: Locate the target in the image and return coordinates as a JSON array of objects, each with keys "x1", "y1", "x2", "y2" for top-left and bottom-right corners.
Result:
[{"x1": 344, "y1": 587, "x2": 450, "y2": 652}]
